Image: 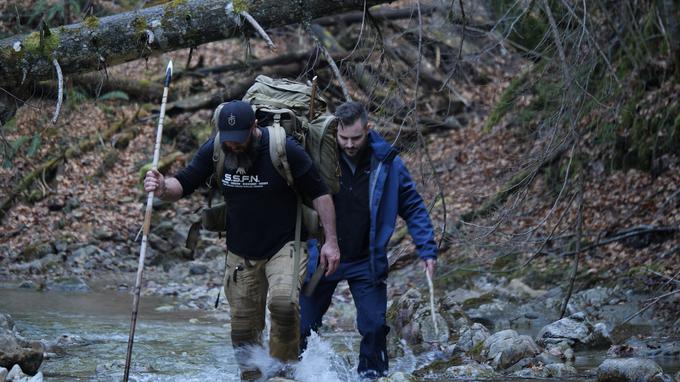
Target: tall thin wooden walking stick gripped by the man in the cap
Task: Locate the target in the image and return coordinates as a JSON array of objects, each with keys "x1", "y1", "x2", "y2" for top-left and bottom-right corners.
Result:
[{"x1": 123, "y1": 60, "x2": 172, "y2": 382}]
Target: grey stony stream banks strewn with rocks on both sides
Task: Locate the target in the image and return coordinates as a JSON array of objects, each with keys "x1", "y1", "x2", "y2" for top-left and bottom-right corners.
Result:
[{"x1": 0, "y1": 206, "x2": 680, "y2": 382}]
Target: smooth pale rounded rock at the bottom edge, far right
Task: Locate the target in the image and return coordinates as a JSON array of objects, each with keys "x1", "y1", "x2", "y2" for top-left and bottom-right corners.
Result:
[{"x1": 597, "y1": 358, "x2": 663, "y2": 382}]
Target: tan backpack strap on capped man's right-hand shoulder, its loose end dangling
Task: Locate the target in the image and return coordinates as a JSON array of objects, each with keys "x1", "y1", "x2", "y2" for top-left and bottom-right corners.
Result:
[{"x1": 267, "y1": 125, "x2": 302, "y2": 300}]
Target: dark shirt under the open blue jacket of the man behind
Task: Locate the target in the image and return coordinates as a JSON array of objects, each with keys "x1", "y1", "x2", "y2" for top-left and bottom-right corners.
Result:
[{"x1": 333, "y1": 146, "x2": 371, "y2": 263}]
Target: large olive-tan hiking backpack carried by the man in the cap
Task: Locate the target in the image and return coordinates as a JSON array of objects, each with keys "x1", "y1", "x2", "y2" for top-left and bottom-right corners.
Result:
[{"x1": 202, "y1": 75, "x2": 340, "y2": 236}]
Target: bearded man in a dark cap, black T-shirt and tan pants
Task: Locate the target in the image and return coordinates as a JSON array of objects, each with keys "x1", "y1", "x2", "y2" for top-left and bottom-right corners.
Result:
[{"x1": 144, "y1": 101, "x2": 340, "y2": 380}]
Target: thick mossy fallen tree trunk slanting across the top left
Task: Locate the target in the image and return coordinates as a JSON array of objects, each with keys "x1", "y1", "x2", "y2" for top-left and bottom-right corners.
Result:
[{"x1": 0, "y1": 0, "x2": 391, "y2": 89}]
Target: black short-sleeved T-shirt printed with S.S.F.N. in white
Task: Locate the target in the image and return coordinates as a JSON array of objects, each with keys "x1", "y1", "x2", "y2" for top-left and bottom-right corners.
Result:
[{"x1": 176, "y1": 129, "x2": 328, "y2": 260}]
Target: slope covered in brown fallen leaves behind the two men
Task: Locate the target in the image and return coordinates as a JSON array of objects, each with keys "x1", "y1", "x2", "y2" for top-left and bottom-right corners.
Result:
[{"x1": 0, "y1": 2, "x2": 680, "y2": 332}]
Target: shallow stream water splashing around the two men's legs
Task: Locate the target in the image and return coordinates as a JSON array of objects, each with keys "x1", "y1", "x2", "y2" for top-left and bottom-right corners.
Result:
[{"x1": 0, "y1": 289, "x2": 677, "y2": 382}]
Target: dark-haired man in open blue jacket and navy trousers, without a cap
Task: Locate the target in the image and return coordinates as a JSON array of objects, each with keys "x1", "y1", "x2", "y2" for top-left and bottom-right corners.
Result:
[{"x1": 300, "y1": 102, "x2": 437, "y2": 379}]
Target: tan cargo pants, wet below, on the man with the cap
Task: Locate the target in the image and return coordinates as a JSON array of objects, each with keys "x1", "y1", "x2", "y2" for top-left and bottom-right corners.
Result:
[{"x1": 224, "y1": 241, "x2": 308, "y2": 379}]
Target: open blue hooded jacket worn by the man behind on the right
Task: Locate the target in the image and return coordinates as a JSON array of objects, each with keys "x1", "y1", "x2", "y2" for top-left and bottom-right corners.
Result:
[{"x1": 307, "y1": 130, "x2": 437, "y2": 282}]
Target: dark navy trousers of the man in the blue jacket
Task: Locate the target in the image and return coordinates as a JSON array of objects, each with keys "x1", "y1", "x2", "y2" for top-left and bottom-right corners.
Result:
[{"x1": 300, "y1": 259, "x2": 390, "y2": 378}]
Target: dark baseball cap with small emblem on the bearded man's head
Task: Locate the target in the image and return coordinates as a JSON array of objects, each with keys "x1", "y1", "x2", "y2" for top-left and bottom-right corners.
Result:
[{"x1": 217, "y1": 101, "x2": 255, "y2": 143}]
